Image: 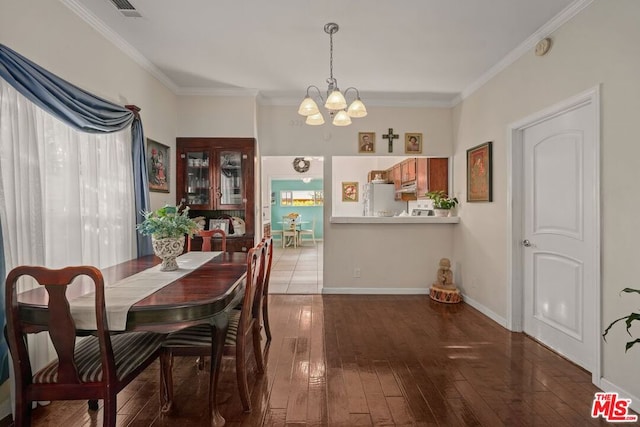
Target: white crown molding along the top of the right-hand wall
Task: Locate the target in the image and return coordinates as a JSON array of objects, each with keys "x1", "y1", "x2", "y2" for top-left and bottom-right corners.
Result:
[{"x1": 454, "y1": 0, "x2": 593, "y2": 105}]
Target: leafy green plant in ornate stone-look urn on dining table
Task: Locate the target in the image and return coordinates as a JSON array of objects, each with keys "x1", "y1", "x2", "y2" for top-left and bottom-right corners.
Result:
[{"x1": 136, "y1": 205, "x2": 200, "y2": 271}]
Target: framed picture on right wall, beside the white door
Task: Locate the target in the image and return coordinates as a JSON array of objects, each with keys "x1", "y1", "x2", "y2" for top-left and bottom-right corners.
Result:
[{"x1": 467, "y1": 142, "x2": 493, "y2": 202}]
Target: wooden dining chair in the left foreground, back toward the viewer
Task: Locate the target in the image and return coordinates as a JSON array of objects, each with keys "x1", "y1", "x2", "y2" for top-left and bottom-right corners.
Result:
[{"x1": 5, "y1": 266, "x2": 164, "y2": 427}]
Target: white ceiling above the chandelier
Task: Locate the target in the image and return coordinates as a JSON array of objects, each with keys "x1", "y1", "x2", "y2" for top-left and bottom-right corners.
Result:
[{"x1": 60, "y1": 0, "x2": 590, "y2": 105}]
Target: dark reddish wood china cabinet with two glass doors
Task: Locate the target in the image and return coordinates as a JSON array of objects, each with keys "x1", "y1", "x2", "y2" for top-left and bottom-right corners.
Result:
[{"x1": 176, "y1": 137, "x2": 255, "y2": 252}]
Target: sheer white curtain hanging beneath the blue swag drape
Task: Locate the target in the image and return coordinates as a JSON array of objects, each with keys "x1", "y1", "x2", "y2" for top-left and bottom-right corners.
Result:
[{"x1": 0, "y1": 79, "x2": 136, "y2": 369}]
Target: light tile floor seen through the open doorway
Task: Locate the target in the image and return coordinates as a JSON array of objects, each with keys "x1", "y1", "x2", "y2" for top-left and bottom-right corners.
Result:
[{"x1": 269, "y1": 239, "x2": 322, "y2": 294}]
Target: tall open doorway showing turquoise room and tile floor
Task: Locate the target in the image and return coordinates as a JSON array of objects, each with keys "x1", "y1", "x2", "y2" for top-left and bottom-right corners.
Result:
[{"x1": 261, "y1": 156, "x2": 324, "y2": 294}]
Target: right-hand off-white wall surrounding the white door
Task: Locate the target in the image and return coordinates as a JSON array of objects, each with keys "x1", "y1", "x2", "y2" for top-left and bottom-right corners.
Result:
[{"x1": 454, "y1": 0, "x2": 640, "y2": 408}]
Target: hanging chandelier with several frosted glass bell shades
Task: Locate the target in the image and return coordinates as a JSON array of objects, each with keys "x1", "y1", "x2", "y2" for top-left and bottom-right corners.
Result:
[{"x1": 298, "y1": 22, "x2": 367, "y2": 126}]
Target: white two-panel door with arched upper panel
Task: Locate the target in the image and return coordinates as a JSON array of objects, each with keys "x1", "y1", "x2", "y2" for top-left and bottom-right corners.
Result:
[{"x1": 522, "y1": 98, "x2": 599, "y2": 372}]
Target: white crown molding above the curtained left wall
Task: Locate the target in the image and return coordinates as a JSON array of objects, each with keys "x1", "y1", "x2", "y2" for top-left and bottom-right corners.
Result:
[{"x1": 60, "y1": 0, "x2": 179, "y2": 94}]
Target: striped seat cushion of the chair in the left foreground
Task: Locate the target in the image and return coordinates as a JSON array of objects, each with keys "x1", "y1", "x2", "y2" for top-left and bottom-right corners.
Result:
[{"x1": 33, "y1": 332, "x2": 166, "y2": 384}]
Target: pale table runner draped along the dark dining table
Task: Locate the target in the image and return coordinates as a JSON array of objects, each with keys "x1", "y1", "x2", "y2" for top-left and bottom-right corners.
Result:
[{"x1": 69, "y1": 251, "x2": 222, "y2": 331}]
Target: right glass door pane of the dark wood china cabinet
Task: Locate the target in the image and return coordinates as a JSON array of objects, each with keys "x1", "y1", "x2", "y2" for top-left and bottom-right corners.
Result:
[{"x1": 218, "y1": 151, "x2": 246, "y2": 209}]
